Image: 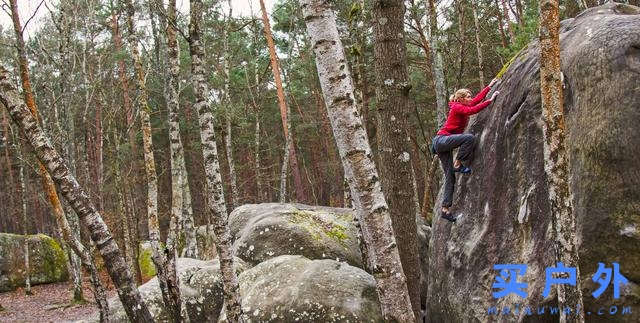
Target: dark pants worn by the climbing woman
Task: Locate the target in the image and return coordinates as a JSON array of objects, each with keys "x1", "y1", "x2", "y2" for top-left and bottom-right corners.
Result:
[{"x1": 433, "y1": 134, "x2": 475, "y2": 207}]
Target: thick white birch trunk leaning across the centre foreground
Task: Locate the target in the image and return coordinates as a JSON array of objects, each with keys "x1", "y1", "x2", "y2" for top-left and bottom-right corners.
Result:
[{"x1": 300, "y1": 0, "x2": 415, "y2": 322}]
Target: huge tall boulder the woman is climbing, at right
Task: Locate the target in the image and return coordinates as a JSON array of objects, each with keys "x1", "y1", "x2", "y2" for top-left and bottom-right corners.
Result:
[{"x1": 428, "y1": 2, "x2": 640, "y2": 322}]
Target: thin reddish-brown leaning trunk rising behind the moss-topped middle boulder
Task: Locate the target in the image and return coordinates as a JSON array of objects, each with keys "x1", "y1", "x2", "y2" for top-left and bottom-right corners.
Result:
[{"x1": 260, "y1": 0, "x2": 307, "y2": 203}]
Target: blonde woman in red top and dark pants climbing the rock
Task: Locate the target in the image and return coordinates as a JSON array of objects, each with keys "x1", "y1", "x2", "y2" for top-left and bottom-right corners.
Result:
[{"x1": 432, "y1": 79, "x2": 500, "y2": 222}]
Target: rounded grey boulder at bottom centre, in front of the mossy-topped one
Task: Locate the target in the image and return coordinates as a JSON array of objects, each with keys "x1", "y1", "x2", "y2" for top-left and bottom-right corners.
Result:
[{"x1": 224, "y1": 255, "x2": 383, "y2": 322}]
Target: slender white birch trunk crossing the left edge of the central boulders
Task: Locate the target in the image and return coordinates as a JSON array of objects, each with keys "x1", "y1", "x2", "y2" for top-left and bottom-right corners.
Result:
[{"x1": 189, "y1": 0, "x2": 245, "y2": 322}]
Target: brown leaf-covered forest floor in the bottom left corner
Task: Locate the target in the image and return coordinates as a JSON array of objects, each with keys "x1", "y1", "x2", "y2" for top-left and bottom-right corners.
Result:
[{"x1": 0, "y1": 273, "x2": 117, "y2": 323}]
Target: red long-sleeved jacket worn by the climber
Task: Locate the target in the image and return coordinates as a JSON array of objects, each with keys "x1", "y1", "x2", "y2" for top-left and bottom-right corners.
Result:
[{"x1": 438, "y1": 86, "x2": 491, "y2": 136}]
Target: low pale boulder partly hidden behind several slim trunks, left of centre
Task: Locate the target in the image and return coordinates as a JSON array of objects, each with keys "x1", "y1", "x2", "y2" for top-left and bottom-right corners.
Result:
[{"x1": 104, "y1": 258, "x2": 246, "y2": 322}]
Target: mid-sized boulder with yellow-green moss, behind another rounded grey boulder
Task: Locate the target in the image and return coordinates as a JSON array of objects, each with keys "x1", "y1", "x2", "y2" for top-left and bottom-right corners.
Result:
[{"x1": 229, "y1": 203, "x2": 362, "y2": 267}]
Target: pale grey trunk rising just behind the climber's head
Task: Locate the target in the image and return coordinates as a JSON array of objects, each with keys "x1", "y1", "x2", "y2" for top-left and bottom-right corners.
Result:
[{"x1": 429, "y1": 0, "x2": 449, "y2": 125}]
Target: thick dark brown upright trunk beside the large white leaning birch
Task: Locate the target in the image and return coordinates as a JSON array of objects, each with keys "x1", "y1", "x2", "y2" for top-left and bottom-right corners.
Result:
[{"x1": 372, "y1": 0, "x2": 420, "y2": 318}]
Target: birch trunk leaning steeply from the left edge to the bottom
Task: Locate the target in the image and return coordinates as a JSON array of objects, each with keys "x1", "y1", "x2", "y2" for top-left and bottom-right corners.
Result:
[{"x1": 0, "y1": 64, "x2": 153, "y2": 322}]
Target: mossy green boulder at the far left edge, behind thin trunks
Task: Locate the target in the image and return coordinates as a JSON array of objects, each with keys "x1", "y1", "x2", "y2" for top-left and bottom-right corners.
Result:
[{"x1": 0, "y1": 233, "x2": 69, "y2": 292}]
